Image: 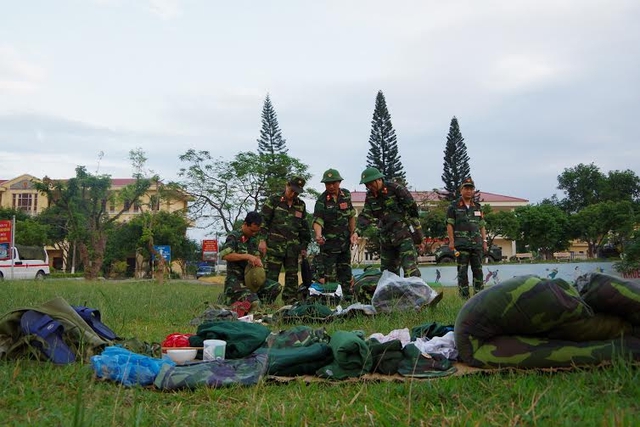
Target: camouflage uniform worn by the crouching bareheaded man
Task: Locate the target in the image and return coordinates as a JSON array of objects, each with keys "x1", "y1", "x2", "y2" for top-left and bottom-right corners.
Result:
[{"x1": 219, "y1": 230, "x2": 280, "y2": 305}]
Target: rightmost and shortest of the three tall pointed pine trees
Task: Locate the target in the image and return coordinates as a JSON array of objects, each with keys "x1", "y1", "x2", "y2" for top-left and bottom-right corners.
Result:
[{"x1": 442, "y1": 116, "x2": 471, "y2": 200}]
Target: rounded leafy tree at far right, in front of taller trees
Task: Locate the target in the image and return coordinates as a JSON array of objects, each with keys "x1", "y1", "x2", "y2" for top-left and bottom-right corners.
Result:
[{"x1": 570, "y1": 201, "x2": 636, "y2": 257}]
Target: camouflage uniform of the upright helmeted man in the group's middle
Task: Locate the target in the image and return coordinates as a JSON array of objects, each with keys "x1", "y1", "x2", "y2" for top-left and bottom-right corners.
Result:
[{"x1": 313, "y1": 188, "x2": 356, "y2": 295}]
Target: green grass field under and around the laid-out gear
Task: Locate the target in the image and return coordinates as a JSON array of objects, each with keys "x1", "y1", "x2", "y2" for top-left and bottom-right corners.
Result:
[{"x1": 0, "y1": 280, "x2": 640, "y2": 427}]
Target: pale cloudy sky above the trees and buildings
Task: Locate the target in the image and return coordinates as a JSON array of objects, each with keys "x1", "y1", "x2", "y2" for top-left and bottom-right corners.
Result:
[{"x1": 0, "y1": 0, "x2": 640, "y2": 236}]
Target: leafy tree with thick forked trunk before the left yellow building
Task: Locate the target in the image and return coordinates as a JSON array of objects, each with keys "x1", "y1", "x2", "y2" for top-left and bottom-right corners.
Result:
[{"x1": 36, "y1": 166, "x2": 150, "y2": 280}]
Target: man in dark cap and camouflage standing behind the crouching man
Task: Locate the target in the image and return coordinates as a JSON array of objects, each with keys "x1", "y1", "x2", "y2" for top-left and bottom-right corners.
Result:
[{"x1": 258, "y1": 177, "x2": 311, "y2": 304}]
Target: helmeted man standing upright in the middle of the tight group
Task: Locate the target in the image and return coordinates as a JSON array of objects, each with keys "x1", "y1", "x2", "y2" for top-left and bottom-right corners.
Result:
[{"x1": 313, "y1": 169, "x2": 356, "y2": 298}]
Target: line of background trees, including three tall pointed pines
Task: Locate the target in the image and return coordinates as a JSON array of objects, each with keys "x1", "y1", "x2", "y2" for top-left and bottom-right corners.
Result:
[{"x1": 5, "y1": 91, "x2": 640, "y2": 279}]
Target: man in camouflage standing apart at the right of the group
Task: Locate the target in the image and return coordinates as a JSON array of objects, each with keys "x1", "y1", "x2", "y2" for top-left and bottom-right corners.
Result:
[{"x1": 447, "y1": 177, "x2": 487, "y2": 298}]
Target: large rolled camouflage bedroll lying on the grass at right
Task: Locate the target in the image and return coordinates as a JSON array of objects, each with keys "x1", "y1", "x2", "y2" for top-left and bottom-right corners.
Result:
[{"x1": 455, "y1": 273, "x2": 640, "y2": 368}]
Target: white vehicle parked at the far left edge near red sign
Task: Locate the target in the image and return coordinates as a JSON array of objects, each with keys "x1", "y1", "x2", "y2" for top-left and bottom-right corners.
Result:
[{"x1": 0, "y1": 245, "x2": 50, "y2": 280}]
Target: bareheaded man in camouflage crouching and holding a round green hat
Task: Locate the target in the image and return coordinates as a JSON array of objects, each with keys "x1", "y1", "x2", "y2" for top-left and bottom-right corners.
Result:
[{"x1": 219, "y1": 212, "x2": 280, "y2": 308}]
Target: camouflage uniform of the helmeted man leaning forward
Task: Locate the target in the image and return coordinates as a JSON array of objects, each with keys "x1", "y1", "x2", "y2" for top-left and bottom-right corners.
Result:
[{"x1": 356, "y1": 181, "x2": 422, "y2": 277}]
